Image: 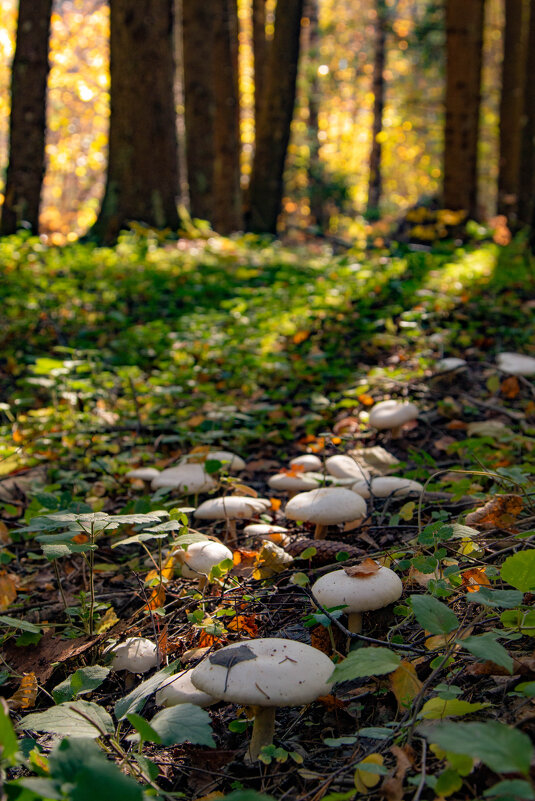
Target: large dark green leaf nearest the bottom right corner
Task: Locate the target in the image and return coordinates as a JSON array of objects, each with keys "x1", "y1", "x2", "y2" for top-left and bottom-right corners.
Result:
[{"x1": 420, "y1": 721, "x2": 533, "y2": 775}]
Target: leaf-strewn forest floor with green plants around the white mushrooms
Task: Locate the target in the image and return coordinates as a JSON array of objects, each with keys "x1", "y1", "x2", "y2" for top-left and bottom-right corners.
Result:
[{"x1": 0, "y1": 232, "x2": 535, "y2": 801}]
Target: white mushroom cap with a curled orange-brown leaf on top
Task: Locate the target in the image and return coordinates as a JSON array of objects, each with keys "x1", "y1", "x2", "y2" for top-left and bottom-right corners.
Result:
[{"x1": 311, "y1": 567, "x2": 403, "y2": 614}]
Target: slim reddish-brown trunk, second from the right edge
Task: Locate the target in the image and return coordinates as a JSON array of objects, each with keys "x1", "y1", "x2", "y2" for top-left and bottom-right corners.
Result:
[{"x1": 498, "y1": 0, "x2": 533, "y2": 221}]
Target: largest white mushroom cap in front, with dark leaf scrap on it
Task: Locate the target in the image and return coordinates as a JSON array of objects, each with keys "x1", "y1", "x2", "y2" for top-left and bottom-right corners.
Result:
[{"x1": 191, "y1": 637, "x2": 334, "y2": 707}]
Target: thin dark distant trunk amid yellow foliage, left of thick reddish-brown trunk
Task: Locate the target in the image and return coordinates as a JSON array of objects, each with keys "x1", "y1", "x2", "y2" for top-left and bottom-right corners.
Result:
[{"x1": 366, "y1": 0, "x2": 388, "y2": 219}]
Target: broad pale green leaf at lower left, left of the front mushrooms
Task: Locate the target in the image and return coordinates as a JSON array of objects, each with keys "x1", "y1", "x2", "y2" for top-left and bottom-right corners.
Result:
[{"x1": 18, "y1": 701, "x2": 113, "y2": 738}]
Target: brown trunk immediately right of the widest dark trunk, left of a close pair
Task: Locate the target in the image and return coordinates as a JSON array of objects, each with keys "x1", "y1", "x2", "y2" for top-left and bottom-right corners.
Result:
[{"x1": 182, "y1": 0, "x2": 216, "y2": 222}]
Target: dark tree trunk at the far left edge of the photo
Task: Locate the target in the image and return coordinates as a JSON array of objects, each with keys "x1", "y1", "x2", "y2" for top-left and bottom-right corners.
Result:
[{"x1": 0, "y1": 0, "x2": 52, "y2": 234}]
